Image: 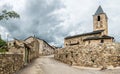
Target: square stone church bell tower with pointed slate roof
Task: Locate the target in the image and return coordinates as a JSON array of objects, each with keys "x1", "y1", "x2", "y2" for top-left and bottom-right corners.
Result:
[{"x1": 93, "y1": 6, "x2": 108, "y2": 35}]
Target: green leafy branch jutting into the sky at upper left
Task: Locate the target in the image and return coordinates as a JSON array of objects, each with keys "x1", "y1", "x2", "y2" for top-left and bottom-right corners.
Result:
[{"x1": 0, "y1": 10, "x2": 20, "y2": 20}]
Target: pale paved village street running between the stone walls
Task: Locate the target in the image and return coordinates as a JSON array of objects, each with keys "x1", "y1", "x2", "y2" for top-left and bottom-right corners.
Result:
[{"x1": 16, "y1": 56, "x2": 120, "y2": 74}]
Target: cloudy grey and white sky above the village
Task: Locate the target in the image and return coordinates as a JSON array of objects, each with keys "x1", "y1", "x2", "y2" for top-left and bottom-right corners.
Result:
[{"x1": 0, "y1": 0, "x2": 120, "y2": 46}]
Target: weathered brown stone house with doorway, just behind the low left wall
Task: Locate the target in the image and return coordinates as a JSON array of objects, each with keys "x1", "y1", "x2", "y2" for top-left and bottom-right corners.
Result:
[{"x1": 7, "y1": 38, "x2": 39, "y2": 64}]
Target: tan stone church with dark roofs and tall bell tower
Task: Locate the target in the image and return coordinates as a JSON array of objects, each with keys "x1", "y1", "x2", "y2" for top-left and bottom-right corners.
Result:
[{"x1": 64, "y1": 6, "x2": 114, "y2": 47}]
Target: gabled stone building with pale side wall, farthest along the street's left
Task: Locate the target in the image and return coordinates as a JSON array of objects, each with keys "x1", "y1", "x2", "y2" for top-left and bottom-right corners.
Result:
[{"x1": 25, "y1": 36, "x2": 54, "y2": 55}]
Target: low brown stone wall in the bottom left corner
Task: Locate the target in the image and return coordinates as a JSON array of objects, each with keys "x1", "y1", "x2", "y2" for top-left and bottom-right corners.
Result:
[{"x1": 0, "y1": 54, "x2": 23, "y2": 74}]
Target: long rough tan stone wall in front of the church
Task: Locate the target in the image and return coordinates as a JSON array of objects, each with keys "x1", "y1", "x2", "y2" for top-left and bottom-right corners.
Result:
[{"x1": 54, "y1": 43, "x2": 120, "y2": 68}]
